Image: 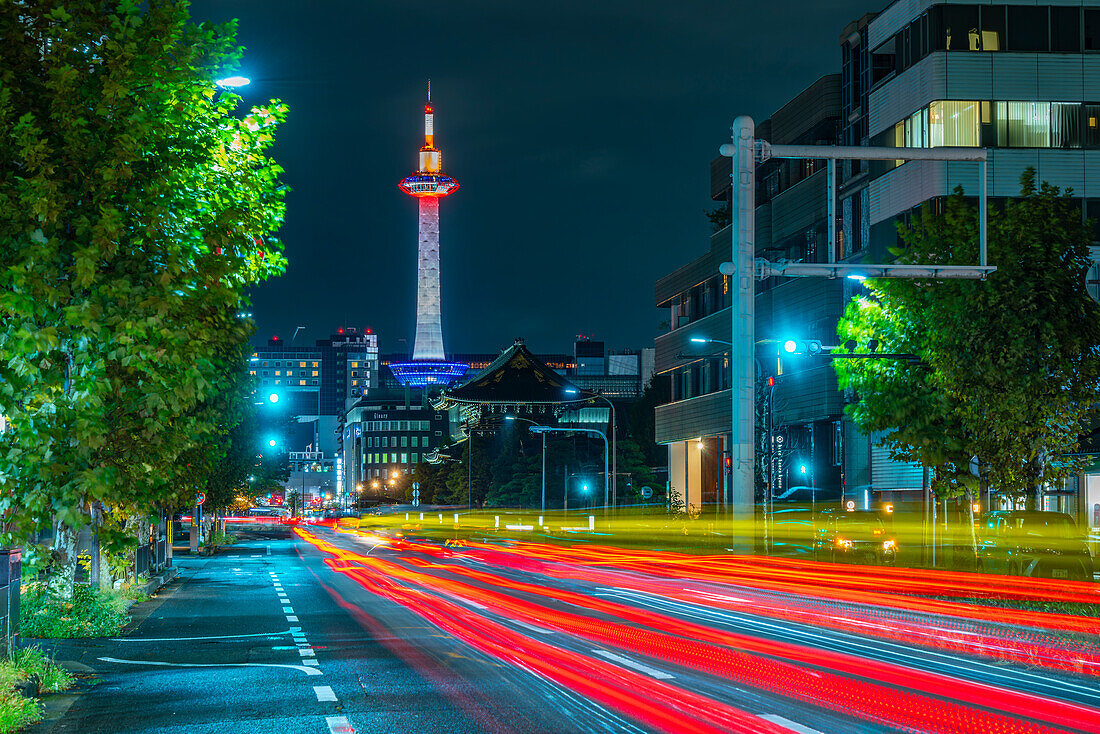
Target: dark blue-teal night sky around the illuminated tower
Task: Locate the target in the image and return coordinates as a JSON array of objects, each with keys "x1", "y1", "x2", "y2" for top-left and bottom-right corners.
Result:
[{"x1": 191, "y1": 0, "x2": 881, "y2": 353}]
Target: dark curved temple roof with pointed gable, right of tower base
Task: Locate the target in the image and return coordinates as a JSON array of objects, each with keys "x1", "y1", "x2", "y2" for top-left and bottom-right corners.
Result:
[{"x1": 437, "y1": 339, "x2": 593, "y2": 406}]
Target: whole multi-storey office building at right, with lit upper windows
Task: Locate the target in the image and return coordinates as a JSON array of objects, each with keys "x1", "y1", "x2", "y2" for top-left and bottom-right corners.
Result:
[{"x1": 656, "y1": 0, "x2": 1100, "y2": 524}]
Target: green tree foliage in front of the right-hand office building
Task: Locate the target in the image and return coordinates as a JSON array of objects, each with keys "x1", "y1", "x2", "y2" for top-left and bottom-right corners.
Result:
[{"x1": 836, "y1": 169, "x2": 1100, "y2": 506}]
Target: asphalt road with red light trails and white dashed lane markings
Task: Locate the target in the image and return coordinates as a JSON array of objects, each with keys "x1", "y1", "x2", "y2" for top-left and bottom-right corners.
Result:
[{"x1": 35, "y1": 528, "x2": 1100, "y2": 734}]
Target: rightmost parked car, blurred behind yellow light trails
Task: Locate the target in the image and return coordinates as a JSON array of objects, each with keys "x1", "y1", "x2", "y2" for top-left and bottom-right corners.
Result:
[{"x1": 978, "y1": 510, "x2": 1093, "y2": 581}]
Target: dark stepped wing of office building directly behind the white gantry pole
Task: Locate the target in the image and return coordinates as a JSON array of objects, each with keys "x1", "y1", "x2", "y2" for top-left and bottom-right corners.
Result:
[{"x1": 656, "y1": 74, "x2": 847, "y2": 513}]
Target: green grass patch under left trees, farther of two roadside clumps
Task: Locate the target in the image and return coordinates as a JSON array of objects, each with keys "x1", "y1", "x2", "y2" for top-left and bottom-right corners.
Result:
[{"x1": 20, "y1": 581, "x2": 130, "y2": 638}]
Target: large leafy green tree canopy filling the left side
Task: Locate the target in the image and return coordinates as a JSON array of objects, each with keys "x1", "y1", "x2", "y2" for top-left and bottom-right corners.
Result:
[{"x1": 0, "y1": 0, "x2": 285, "y2": 574}]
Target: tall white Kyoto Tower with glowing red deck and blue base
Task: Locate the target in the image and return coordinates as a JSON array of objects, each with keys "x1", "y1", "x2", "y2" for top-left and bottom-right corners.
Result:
[{"x1": 389, "y1": 80, "x2": 466, "y2": 387}]
